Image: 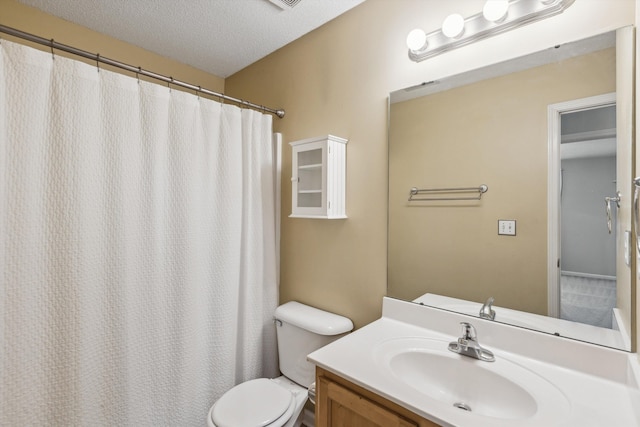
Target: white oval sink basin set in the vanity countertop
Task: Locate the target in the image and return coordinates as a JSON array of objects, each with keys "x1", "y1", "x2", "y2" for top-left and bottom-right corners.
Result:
[{"x1": 374, "y1": 338, "x2": 569, "y2": 421}]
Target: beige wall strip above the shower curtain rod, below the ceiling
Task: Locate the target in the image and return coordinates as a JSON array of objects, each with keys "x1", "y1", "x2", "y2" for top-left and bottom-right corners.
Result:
[{"x1": 0, "y1": 0, "x2": 224, "y2": 92}]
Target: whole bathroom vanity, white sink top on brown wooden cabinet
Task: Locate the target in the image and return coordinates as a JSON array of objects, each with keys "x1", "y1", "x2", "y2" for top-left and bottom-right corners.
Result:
[{"x1": 308, "y1": 298, "x2": 640, "y2": 427}]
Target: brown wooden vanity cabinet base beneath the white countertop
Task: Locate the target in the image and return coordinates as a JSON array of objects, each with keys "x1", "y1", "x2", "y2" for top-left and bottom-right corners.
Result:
[{"x1": 316, "y1": 368, "x2": 438, "y2": 427}]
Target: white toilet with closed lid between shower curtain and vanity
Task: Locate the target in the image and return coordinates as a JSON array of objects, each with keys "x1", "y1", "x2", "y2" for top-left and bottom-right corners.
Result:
[{"x1": 207, "y1": 301, "x2": 353, "y2": 427}]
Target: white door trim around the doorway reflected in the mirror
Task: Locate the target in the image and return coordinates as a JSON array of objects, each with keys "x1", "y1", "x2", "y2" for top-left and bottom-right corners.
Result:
[{"x1": 547, "y1": 92, "x2": 616, "y2": 317}]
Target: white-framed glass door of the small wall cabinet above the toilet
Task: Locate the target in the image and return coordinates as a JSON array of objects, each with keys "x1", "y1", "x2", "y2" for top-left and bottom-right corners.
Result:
[{"x1": 291, "y1": 142, "x2": 327, "y2": 216}]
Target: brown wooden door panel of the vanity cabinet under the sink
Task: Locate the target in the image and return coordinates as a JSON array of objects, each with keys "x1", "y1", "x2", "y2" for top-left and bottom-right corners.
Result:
[{"x1": 317, "y1": 378, "x2": 418, "y2": 427}]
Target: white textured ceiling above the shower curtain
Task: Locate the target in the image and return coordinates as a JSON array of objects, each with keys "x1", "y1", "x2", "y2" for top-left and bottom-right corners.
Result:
[{"x1": 19, "y1": 0, "x2": 364, "y2": 77}]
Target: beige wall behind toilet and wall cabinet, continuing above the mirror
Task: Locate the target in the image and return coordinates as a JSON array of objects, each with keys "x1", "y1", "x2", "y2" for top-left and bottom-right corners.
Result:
[{"x1": 226, "y1": 0, "x2": 635, "y2": 327}]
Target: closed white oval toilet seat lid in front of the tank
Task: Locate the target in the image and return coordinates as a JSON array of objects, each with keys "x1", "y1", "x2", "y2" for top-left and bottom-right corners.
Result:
[{"x1": 210, "y1": 378, "x2": 295, "y2": 427}]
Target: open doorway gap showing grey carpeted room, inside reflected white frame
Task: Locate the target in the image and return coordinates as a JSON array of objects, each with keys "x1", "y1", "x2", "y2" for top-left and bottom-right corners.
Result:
[{"x1": 559, "y1": 103, "x2": 619, "y2": 329}]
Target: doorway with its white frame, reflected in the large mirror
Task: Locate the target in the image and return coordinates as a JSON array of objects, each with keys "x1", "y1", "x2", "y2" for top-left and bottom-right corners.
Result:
[{"x1": 548, "y1": 93, "x2": 630, "y2": 329}]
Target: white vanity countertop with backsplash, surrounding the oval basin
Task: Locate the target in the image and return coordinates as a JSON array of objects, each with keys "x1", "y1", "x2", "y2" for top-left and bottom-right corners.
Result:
[{"x1": 308, "y1": 298, "x2": 640, "y2": 427}]
